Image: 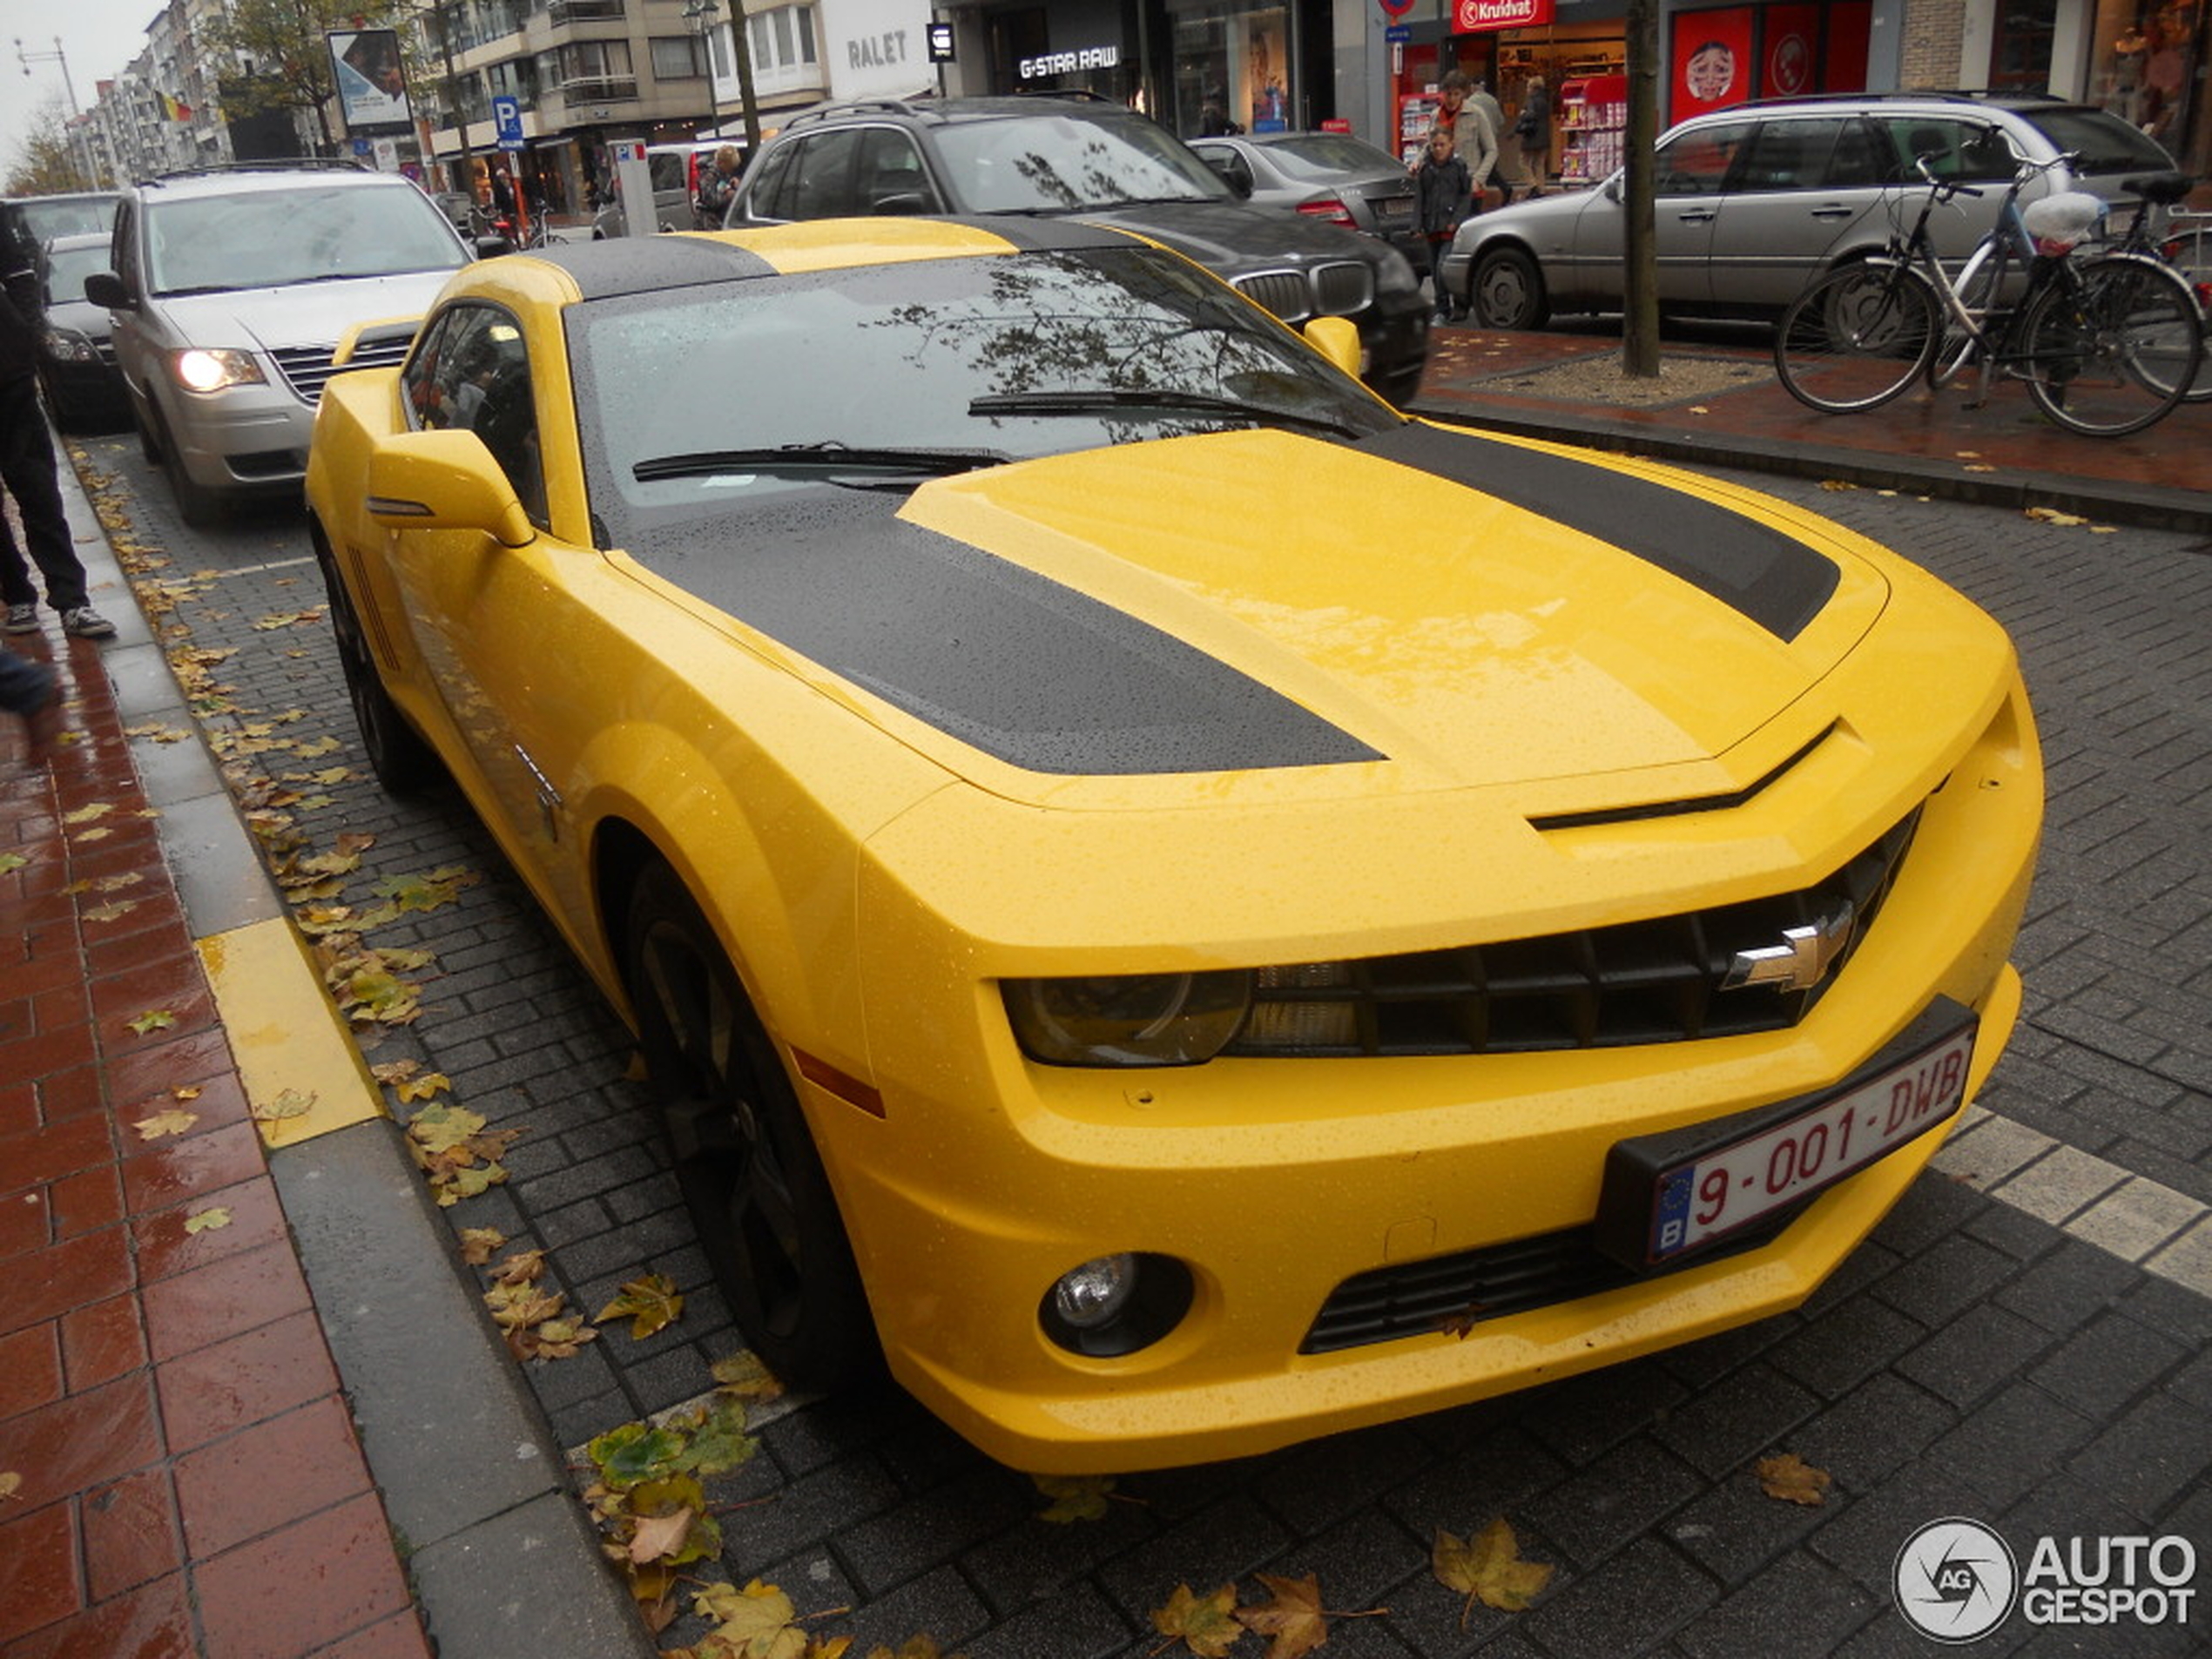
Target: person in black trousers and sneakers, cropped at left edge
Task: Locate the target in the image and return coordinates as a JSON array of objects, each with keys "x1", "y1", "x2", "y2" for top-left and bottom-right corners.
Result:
[{"x1": 0, "y1": 247, "x2": 115, "y2": 639}]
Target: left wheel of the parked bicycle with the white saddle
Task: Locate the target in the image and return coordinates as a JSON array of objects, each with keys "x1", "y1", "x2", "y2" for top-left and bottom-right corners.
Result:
[{"x1": 1774, "y1": 261, "x2": 1942, "y2": 414}]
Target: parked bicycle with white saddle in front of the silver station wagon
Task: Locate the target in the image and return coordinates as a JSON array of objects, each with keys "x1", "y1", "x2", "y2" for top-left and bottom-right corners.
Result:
[{"x1": 1774, "y1": 155, "x2": 2203, "y2": 438}]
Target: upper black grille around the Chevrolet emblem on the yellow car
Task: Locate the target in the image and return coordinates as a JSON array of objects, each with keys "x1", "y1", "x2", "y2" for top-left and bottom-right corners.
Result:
[{"x1": 1225, "y1": 810, "x2": 1920, "y2": 1057}]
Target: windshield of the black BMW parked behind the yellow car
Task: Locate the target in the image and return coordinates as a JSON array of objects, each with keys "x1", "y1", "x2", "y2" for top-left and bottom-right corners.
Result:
[{"x1": 935, "y1": 115, "x2": 1234, "y2": 212}]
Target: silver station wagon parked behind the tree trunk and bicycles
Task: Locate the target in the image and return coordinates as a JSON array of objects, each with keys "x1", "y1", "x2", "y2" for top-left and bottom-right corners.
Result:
[{"x1": 1442, "y1": 93, "x2": 2172, "y2": 327}]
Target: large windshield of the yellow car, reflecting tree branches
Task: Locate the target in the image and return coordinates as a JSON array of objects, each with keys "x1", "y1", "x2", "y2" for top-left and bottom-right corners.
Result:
[{"x1": 569, "y1": 247, "x2": 1400, "y2": 546}]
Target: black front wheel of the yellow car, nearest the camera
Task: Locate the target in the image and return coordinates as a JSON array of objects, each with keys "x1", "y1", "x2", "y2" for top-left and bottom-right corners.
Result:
[{"x1": 622, "y1": 865, "x2": 880, "y2": 1392}]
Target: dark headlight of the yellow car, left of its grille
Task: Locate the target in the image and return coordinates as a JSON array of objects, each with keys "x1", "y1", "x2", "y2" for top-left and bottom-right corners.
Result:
[{"x1": 1004, "y1": 971, "x2": 1252, "y2": 1066}]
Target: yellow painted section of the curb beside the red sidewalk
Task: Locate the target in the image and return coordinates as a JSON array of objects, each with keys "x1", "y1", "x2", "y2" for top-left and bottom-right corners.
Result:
[{"x1": 197, "y1": 918, "x2": 388, "y2": 1148}]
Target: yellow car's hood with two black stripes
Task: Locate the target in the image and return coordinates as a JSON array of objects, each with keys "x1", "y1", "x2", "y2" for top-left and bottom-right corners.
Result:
[{"x1": 631, "y1": 422, "x2": 1887, "y2": 799}]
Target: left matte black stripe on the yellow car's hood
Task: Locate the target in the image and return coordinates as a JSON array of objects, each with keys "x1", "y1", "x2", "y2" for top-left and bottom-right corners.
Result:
[{"x1": 631, "y1": 489, "x2": 1383, "y2": 777}]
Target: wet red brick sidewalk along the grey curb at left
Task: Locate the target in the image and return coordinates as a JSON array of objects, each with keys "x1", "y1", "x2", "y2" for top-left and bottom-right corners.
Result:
[{"x1": 0, "y1": 579, "x2": 429, "y2": 1659}]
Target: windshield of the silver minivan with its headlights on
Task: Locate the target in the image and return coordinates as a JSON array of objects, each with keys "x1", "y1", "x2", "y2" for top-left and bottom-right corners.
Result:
[{"x1": 146, "y1": 184, "x2": 469, "y2": 294}]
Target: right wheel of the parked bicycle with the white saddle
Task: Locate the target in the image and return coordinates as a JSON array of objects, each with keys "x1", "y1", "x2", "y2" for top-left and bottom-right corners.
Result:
[{"x1": 2011, "y1": 254, "x2": 2203, "y2": 438}]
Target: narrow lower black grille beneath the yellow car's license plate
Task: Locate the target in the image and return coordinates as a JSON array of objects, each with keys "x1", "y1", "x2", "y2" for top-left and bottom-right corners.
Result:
[{"x1": 1298, "y1": 1205, "x2": 1803, "y2": 1353}]
